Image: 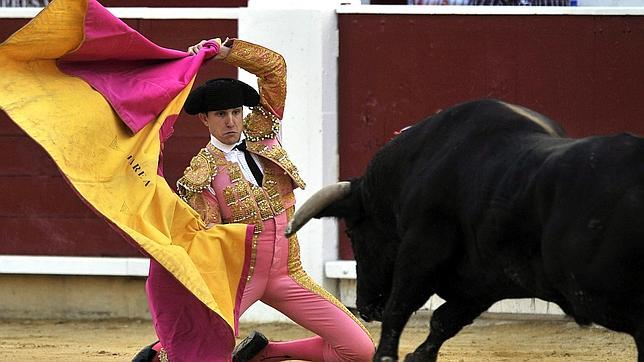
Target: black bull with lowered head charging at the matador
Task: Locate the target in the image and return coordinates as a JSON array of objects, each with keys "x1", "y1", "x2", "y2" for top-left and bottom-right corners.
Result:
[{"x1": 289, "y1": 100, "x2": 644, "y2": 361}]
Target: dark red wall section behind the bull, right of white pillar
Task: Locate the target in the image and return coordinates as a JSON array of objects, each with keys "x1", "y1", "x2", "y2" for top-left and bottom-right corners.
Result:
[{"x1": 338, "y1": 14, "x2": 644, "y2": 258}]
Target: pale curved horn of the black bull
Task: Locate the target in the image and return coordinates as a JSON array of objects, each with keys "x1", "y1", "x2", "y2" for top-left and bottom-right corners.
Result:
[{"x1": 284, "y1": 181, "x2": 351, "y2": 237}]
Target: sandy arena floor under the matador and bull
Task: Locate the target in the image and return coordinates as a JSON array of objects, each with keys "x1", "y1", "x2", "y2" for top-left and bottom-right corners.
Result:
[{"x1": 0, "y1": 319, "x2": 636, "y2": 362}]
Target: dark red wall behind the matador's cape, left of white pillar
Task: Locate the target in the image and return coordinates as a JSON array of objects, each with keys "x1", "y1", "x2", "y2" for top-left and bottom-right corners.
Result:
[{"x1": 0, "y1": 19, "x2": 237, "y2": 256}]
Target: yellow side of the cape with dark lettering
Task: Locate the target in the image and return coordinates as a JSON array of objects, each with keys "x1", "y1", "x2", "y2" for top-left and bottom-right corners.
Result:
[{"x1": 0, "y1": 0, "x2": 247, "y2": 327}]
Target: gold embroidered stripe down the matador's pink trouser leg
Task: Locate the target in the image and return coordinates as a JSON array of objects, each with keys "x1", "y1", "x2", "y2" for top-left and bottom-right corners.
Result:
[{"x1": 286, "y1": 207, "x2": 373, "y2": 341}]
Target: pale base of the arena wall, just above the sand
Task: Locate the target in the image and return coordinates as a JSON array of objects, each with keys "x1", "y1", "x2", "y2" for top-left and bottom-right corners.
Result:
[{"x1": 0, "y1": 274, "x2": 565, "y2": 325}]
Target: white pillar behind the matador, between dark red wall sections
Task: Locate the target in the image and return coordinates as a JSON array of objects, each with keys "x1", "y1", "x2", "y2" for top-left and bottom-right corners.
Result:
[{"x1": 238, "y1": 0, "x2": 338, "y2": 321}]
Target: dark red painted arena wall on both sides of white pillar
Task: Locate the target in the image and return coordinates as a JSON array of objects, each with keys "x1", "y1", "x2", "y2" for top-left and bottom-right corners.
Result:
[{"x1": 5, "y1": 12, "x2": 644, "y2": 258}]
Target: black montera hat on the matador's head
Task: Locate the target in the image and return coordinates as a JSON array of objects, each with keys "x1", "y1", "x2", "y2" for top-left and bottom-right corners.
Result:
[{"x1": 183, "y1": 78, "x2": 259, "y2": 114}]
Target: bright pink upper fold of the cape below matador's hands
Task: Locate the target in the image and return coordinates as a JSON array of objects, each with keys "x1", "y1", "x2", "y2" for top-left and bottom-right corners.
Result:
[{"x1": 58, "y1": 0, "x2": 219, "y2": 133}]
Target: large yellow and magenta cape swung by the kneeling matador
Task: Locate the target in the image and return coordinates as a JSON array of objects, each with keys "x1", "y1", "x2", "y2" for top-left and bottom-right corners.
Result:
[{"x1": 0, "y1": 0, "x2": 252, "y2": 348}]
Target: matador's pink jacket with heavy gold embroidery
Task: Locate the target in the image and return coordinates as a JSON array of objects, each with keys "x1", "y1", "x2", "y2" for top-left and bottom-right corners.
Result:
[{"x1": 177, "y1": 39, "x2": 305, "y2": 233}]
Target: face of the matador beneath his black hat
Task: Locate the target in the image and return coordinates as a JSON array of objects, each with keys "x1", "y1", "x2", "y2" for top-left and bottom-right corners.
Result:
[{"x1": 199, "y1": 106, "x2": 244, "y2": 145}]
